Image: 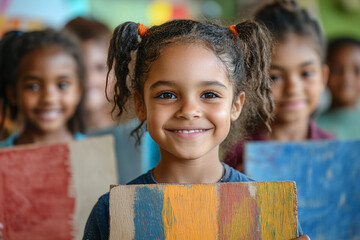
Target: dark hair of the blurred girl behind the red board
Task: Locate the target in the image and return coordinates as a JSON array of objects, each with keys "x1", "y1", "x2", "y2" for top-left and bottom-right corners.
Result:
[{"x1": 0, "y1": 29, "x2": 85, "y2": 133}]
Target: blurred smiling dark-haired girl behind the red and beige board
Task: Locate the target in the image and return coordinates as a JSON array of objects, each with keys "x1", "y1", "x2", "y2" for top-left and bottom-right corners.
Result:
[{"x1": 0, "y1": 29, "x2": 84, "y2": 147}]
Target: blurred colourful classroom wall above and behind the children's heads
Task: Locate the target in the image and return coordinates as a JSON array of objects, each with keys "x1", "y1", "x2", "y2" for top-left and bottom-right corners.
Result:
[{"x1": 0, "y1": 0, "x2": 360, "y2": 38}]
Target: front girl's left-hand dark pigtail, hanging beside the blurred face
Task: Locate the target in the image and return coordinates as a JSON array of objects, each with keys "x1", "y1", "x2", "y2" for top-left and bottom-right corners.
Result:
[{"x1": 106, "y1": 22, "x2": 139, "y2": 116}]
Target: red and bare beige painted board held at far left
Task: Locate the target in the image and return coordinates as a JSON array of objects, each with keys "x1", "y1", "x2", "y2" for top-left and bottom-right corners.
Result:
[{"x1": 0, "y1": 136, "x2": 117, "y2": 240}]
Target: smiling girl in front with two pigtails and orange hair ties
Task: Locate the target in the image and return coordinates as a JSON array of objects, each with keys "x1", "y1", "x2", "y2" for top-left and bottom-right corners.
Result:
[{"x1": 83, "y1": 20, "x2": 308, "y2": 240}]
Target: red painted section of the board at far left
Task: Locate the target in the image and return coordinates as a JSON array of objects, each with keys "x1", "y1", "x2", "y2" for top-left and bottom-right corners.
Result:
[{"x1": 0, "y1": 144, "x2": 75, "y2": 240}]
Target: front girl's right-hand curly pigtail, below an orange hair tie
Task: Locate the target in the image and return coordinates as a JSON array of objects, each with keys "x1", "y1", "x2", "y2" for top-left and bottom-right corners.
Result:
[{"x1": 235, "y1": 20, "x2": 274, "y2": 131}]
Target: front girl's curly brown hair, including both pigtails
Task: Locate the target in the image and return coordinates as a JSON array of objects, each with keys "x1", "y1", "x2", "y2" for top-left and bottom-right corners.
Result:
[{"x1": 107, "y1": 20, "x2": 273, "y2": 148}]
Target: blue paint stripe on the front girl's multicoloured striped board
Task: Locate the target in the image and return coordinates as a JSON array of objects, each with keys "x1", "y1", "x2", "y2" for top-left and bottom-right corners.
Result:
[{"x1": 134, "y1": 187, "x2": 165, "y2": 240}]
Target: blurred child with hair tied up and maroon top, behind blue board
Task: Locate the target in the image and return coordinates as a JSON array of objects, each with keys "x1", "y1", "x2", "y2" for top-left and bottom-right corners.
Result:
[{"x1": 224, "y1": 0, "x2": 334, "y2": 172}]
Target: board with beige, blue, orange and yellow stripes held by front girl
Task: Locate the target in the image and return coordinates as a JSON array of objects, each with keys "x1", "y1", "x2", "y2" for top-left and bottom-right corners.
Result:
[{"x1": 110, "y1": 182, "x2": 298, "y2": 240}]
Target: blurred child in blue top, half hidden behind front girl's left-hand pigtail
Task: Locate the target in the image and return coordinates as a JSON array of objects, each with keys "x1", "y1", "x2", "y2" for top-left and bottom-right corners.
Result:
[{"x1": 64, "y1": 17, "x2": 160, "y2": 184}]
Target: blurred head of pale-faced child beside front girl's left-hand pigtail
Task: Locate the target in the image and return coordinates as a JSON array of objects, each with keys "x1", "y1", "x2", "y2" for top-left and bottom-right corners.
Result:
[{"x1": 64, "y1": 17, "x2": 129, "y2": 132}]
